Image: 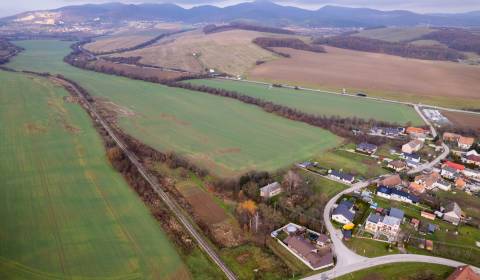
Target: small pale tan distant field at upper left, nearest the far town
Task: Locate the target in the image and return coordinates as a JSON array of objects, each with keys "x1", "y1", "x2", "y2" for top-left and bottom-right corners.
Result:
[{"x1": 85, "y1": 34, "x2": 158, "y2": 52}]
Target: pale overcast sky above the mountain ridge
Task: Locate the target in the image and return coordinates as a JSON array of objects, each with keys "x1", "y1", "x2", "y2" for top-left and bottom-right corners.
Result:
[{"x1": 0, "y1": 0, "x2": 480, "y2": 16}]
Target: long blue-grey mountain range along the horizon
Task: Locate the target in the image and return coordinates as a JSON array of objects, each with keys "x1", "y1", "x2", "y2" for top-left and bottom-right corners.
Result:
[{"x1": 2, "y1": 1, "x2": 480, "y2": 27}]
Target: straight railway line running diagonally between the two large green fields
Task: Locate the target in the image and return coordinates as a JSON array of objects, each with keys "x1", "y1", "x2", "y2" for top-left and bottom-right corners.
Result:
[{"x1": 52, "y1": 78, "x2": 237, "y2": 280}]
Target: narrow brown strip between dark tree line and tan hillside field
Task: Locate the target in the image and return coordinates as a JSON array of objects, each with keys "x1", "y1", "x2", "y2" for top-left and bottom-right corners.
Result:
[{"x1": 91, "y1": 60, "x2": 186, "y2": 79}]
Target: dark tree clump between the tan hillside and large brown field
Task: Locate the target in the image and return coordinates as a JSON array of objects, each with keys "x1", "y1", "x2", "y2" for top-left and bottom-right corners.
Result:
[{"x1": 252, "y1": 37, "x2": 325, "y2": 57}]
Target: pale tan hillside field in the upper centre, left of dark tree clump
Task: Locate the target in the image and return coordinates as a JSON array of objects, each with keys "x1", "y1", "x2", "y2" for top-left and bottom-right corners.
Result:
[{"x1": 114, "y1": 30, "x2": 298, "y2": 75}]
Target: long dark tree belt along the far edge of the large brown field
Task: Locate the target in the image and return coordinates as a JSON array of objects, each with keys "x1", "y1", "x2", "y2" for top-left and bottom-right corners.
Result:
[{"x1": 313, "y1": 36, "x2": 465, "y2": 61}]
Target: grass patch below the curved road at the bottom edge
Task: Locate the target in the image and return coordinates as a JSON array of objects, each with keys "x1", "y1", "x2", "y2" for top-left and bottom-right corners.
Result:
[{"x1": 335, "y1": 263, "x2": 454, "y2": 280}]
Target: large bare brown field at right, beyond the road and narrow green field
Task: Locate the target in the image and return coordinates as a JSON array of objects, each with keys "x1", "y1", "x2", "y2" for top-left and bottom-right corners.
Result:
[{"x1": 249, "y1": 47, "x2": 480, "y2": 108}]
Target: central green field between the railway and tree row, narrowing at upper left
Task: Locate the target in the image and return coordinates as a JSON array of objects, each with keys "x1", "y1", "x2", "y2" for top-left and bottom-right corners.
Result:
[{"x1": 8, "y1": 41, "x2": 341, "y2": 175}]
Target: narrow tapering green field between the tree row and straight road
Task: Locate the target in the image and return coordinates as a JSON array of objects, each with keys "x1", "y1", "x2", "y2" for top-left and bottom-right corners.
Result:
[{"x1": 189, "y1": 79, "x2": 423, "y2": 125}]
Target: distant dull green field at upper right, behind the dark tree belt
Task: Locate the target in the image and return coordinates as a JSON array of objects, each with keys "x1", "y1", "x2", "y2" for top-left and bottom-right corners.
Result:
[{"x1": 352, "y1": 26, "x2": 435, "y2": 42}]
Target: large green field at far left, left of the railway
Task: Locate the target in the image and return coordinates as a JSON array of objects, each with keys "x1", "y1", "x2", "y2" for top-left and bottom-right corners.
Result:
[{"x1": 0, "y1": 71, "x2": 191, "y2": 280}]
